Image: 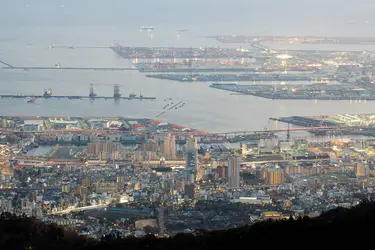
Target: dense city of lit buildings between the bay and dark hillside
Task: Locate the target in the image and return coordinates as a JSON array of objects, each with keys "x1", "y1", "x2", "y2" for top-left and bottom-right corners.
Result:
[{"x1": 0, "y1": 114, "x2": 375, "y2": 239}]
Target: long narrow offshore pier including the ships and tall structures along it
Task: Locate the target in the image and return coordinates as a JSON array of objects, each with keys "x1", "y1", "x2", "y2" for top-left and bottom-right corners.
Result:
[{"x1": 0, "y1": 84, "x2": 156, "y2": 103}]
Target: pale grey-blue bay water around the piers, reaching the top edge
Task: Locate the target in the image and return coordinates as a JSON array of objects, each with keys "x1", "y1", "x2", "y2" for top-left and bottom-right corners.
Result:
[{"x1": 0, "y1": 0, "x2": 375, "y2": 131}]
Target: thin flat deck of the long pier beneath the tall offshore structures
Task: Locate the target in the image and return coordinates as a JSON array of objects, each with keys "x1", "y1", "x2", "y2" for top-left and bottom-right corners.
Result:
[{"x1": 0, "y1": 95, "x2": 156, "y2": 101}]
